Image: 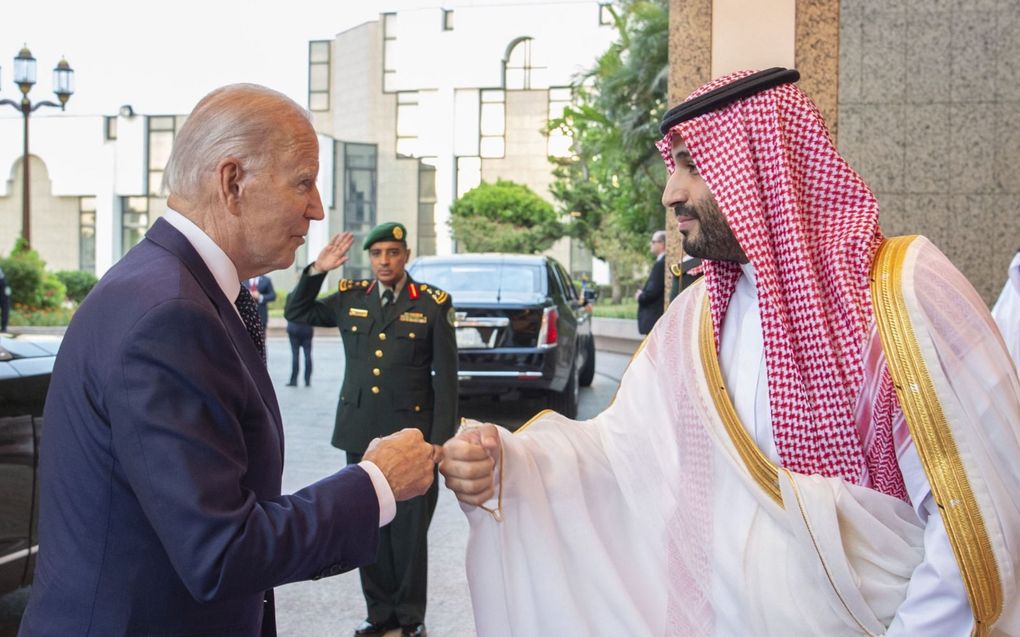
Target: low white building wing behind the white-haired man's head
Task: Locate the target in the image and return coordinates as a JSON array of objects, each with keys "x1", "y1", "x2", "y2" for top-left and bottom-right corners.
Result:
[{"x1": 0, "y1": 107, "x2": 385, "y2": 289}]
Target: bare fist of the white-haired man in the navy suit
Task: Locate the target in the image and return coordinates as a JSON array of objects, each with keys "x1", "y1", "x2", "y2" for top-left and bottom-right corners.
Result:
[{"x1": 361, "y1": 428, "x2": 443, "y2": 502}]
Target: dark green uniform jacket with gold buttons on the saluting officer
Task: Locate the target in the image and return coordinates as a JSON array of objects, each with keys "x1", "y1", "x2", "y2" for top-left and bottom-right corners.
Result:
[{"x1": 286, "y1": 268, "x2": 457, "y2": 454}]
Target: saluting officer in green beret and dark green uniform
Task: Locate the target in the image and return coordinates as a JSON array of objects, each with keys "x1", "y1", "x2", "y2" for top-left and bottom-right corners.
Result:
[{"x1": 286, "y1": 222, "x2": 457, "y2": 637}]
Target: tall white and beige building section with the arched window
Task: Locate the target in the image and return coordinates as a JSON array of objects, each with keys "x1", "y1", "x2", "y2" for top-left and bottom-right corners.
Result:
[{"x1": 308, "y1": 1, "x2": 616, "y2": 274}]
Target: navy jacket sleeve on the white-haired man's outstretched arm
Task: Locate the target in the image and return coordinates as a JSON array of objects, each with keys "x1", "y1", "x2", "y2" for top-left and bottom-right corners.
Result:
[{"x1": 104, "y1": 299, "x2": 378, "y2": 601}]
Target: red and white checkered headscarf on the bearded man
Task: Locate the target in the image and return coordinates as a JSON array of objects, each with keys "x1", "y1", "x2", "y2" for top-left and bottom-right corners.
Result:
[{"x1": 657, "y1": 71, "x2": 906, "y2": 497}]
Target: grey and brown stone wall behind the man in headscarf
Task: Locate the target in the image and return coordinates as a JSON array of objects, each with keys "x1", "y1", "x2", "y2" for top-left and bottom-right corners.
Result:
[{"x1": 669, "y1": 0, "x2": 1020, "y2": 303}]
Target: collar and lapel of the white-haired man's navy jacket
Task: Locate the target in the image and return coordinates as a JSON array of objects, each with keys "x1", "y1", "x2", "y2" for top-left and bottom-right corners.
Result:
[{"x1": 145, "y1": 219, "x2": 284, "y2": 456}]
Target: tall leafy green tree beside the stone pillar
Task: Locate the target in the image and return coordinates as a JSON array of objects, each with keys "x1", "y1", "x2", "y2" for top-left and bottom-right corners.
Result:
[{"x1": 550, "y1": 0, "x2": 669, "y2": 303}]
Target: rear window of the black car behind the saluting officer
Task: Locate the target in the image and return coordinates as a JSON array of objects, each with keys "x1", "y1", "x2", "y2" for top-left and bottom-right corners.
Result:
[{"x1": 412, "y1": 262, "x2": 545, "y2": 299}]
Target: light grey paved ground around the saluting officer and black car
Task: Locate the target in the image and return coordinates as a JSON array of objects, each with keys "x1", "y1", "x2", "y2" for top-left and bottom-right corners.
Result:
[{"x1": 0, "y1": 336, "x2": 630, "y2": 637}]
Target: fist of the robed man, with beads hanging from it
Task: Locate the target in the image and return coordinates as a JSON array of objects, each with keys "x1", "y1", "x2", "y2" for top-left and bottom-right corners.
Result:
[{"x1": 440, "y1": 424, "x2": 502, "y2": 507}]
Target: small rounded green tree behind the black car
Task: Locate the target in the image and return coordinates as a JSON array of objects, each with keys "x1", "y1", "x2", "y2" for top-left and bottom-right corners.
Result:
[{"x1": 450, "y1": 179, "x2": 564, "y2": 254}]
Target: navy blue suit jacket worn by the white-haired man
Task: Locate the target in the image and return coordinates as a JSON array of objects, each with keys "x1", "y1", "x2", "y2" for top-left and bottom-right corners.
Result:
[{"x1": 20, "y1": 219, "x2": 378, "y2": 637}]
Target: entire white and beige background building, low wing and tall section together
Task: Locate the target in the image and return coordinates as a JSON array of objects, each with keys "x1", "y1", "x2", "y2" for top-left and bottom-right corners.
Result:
[{"x1": 0, "y1": 0, "x2": 615, "y2": 289}]
